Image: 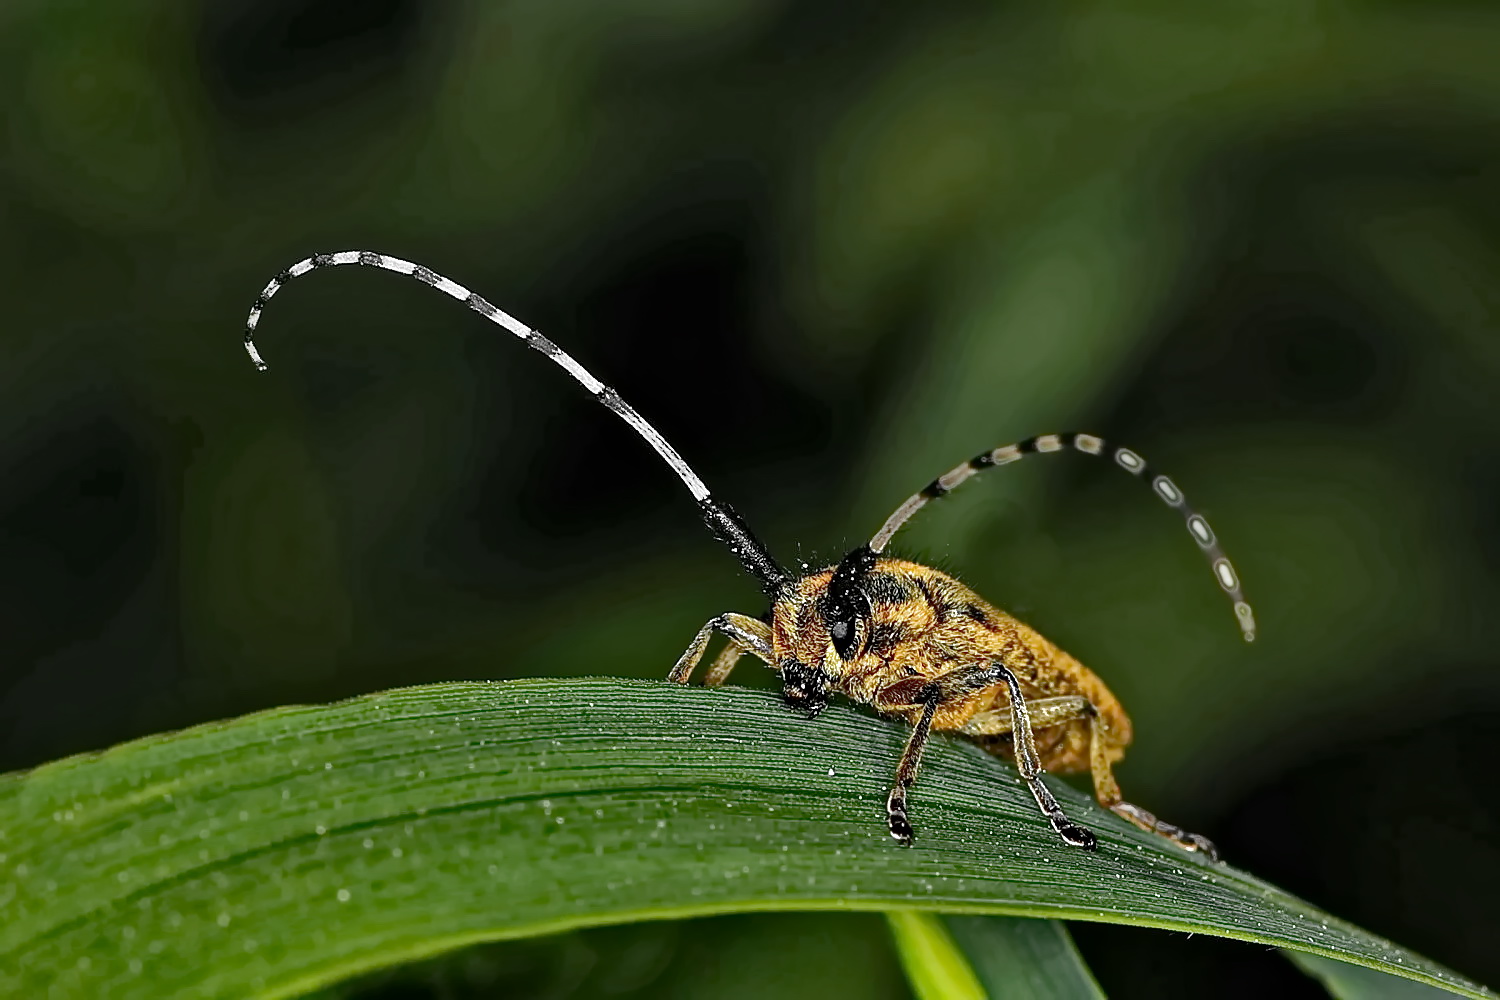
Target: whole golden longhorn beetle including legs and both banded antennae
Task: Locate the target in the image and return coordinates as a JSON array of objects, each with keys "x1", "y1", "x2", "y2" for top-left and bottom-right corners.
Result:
[{"x1": 245, "y1": 250, "x2": 1256, "y2": 861}]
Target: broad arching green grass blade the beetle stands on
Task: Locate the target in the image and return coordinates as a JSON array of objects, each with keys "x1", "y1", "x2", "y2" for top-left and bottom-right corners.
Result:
[{"x1": 0, "y1": 679, "x2": 1491, "y2": 1000}]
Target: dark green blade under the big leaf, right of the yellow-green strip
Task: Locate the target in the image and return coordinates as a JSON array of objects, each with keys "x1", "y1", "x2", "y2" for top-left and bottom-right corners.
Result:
[{"x1": 944, "y1": 916, "x2": 1104, "y2": 1000}]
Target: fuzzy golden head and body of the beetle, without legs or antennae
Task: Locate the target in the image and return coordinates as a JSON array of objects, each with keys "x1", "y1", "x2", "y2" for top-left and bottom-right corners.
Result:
[{"x1": 771, "y1": 558, "x2": 1131, "y2": 774}]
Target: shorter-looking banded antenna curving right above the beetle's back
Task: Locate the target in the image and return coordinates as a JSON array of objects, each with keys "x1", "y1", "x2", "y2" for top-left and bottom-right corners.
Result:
[{"x1": 870, "y1": 433, "x2": 1256, "y2": 642}]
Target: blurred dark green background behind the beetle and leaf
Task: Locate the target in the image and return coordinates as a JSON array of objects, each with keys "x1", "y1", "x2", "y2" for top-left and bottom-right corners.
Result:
[{"x1": 0, "y1": 0, "x2": 1500, "y2": 1000}]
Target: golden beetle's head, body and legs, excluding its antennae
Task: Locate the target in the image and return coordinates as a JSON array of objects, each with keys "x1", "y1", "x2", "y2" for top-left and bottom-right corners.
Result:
[{"x1": 669, "y1": 546, "x2": 1217, "y2": 858}]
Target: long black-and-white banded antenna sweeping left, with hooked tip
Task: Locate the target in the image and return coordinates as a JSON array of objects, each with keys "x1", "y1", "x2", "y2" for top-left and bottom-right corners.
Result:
[{"x1": 245, "y1": 250, "x2": 789, "y2": 595}]
